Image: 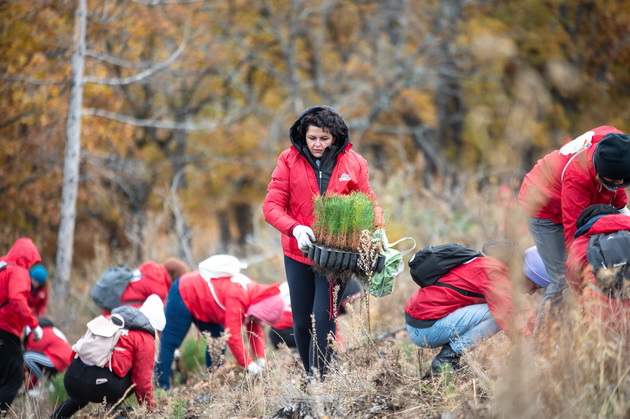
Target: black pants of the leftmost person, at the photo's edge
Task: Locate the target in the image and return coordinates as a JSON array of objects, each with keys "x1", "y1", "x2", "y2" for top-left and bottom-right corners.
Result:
[{"x1": 0, "y1": 330, "x2": 24, "y2": 416}]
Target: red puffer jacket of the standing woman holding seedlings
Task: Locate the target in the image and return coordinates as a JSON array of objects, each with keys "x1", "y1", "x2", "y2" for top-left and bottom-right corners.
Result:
[{"x1": 263, "y1": 143, "x2": 383, "y2": 264}]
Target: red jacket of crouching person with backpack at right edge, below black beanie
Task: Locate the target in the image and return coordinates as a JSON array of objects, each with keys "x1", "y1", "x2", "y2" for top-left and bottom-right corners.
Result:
[{"x1": 565, "y1": 214, "x2": 630, "y2": 319}]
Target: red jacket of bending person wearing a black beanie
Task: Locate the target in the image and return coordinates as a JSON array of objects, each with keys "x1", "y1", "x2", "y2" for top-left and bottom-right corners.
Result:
[{"x1": 518, "y1": 126, "x2": 628, "y2": 249}]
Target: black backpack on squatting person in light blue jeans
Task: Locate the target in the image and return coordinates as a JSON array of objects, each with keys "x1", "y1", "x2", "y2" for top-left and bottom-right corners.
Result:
[{"x1": 408, "y1": 243, "x2": 484, "y2": 298}]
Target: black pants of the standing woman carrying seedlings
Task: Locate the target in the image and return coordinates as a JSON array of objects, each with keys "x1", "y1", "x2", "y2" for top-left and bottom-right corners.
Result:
[{"x1": 284, "y1": 256, "x2": 346, "y2": 376}]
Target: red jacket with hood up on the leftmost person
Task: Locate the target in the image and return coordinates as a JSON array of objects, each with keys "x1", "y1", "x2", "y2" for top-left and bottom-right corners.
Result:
[{"x1": 0, "y1": 238, "x2": 42, "y2": 337}]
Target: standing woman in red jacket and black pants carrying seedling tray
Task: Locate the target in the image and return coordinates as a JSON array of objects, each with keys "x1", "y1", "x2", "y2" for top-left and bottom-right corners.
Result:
[{"x1": 263, "y1": 106, "x2": 386, "y2": 376}]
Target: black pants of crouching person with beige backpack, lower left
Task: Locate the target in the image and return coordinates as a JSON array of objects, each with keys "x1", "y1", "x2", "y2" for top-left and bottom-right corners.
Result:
[{"x1": 52, "y1": 359, "x2": 134, "y2": 419}]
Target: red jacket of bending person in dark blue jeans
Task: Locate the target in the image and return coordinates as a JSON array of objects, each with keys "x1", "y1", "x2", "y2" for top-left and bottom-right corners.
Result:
[{"x1": 178, "y1": 271, "x2": 280, "y2": 367}]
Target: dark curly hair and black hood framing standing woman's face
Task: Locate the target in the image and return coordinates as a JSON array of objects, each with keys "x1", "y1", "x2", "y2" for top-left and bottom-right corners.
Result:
[{"x1": 290, "y1": 106, "x2": 350, "y2": 144}]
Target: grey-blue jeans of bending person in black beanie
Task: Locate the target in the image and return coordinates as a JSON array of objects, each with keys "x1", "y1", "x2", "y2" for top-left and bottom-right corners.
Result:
[{"x1": 527, "y1": 216, "x2": 567, "y2": 335}]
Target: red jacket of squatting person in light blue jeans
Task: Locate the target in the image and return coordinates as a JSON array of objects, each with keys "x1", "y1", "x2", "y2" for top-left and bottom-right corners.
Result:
[{"x1": 405, "y1": 256, "x2": 535, "y2": 337}]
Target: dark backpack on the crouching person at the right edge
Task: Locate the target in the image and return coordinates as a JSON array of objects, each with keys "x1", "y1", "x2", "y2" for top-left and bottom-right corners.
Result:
[{"x1": 586, "y1": 230, "x2": 630, "y2": 295}]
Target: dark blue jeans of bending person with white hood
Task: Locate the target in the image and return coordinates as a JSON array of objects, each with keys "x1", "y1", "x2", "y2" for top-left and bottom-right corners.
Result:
[{"x1": 155, "y1": 279, "x2": 224, "y2": 389}]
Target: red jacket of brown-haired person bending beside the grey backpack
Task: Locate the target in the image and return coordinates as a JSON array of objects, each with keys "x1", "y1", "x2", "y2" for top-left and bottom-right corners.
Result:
[{"x1": 120, "y1": 261, "x2": 171, "y2": 308}]
